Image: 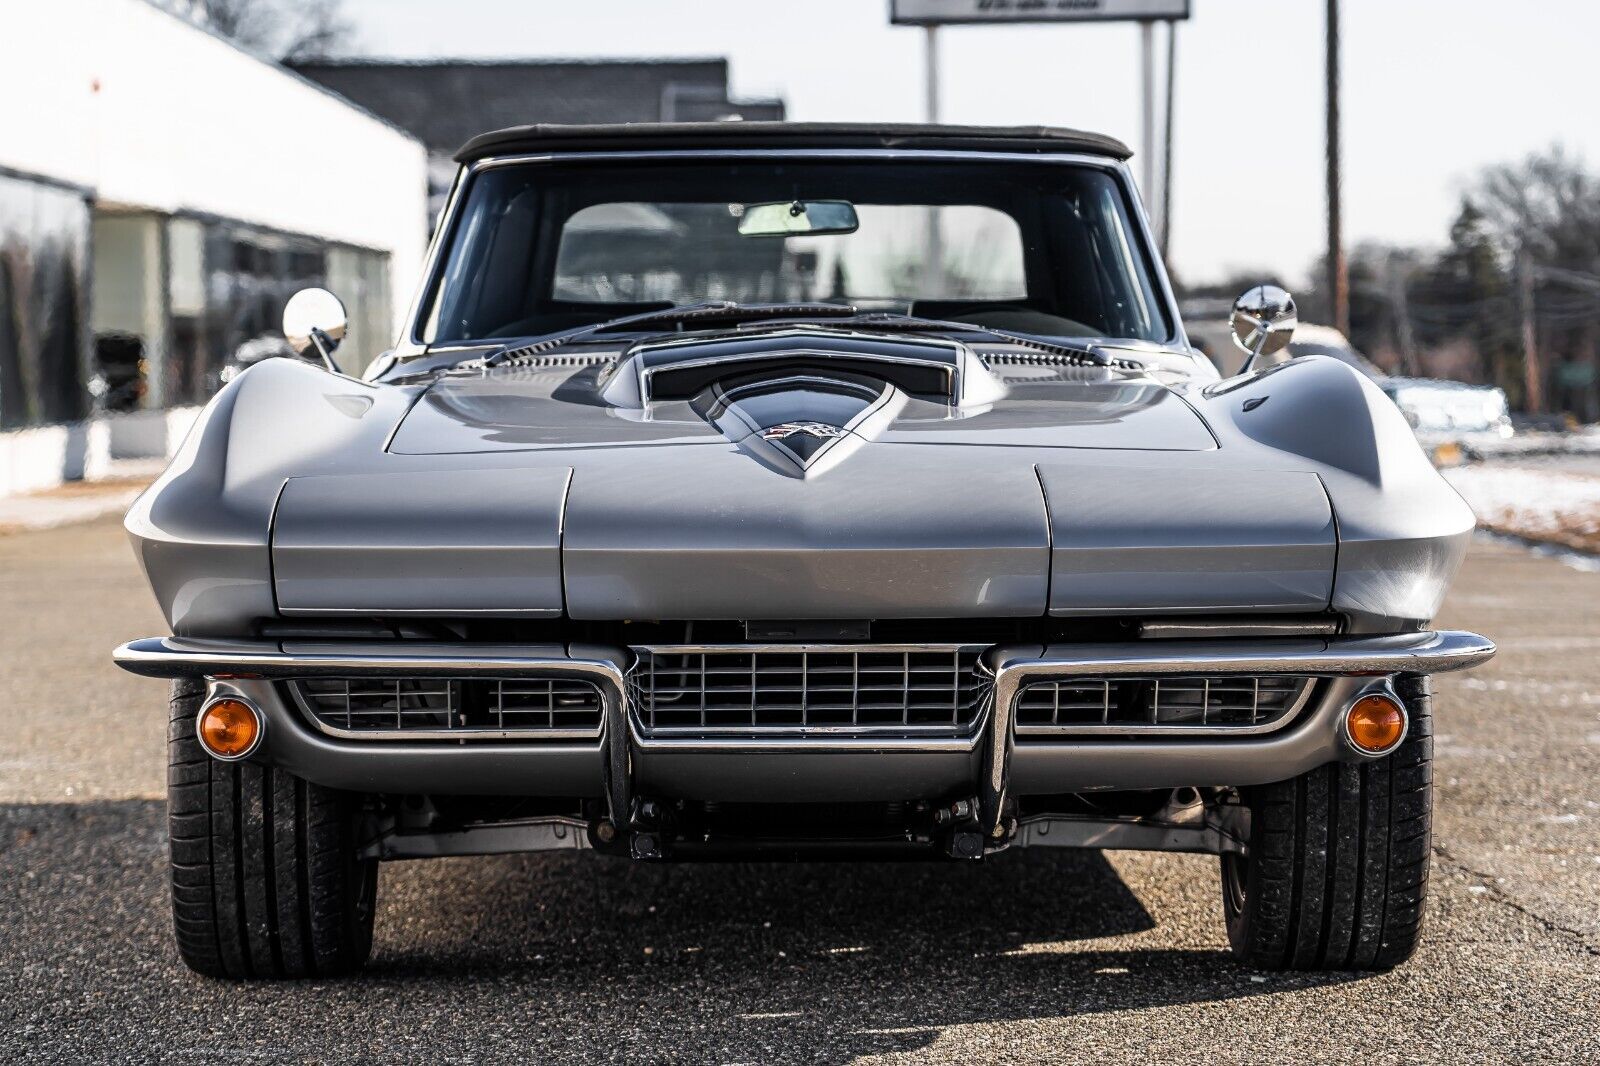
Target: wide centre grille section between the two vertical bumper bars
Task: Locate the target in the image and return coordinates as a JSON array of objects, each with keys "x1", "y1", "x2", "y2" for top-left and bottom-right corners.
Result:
[{"x1": 629, "y1": 645, "x2": 990, "y2": 736}]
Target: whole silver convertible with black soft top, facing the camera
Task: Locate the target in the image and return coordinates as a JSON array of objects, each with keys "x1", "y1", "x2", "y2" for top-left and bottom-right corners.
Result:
[{"x1": 115, "y1": 123, "x2": 1494, "y2": 978}]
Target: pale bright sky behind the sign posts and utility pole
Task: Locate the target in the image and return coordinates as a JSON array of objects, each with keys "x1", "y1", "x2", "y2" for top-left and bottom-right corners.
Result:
[{"x1": 346, "y1": 0, "x2": 1600, "y2": 283}]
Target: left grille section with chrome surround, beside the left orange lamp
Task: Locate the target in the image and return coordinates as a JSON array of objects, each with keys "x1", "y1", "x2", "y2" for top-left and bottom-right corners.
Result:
[{"x1": 290, "y1": 677, "x2": 603, "y2": 739}]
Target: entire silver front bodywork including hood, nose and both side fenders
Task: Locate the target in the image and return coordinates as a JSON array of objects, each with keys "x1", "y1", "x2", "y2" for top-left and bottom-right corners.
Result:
[{"x1": 128, "y1": 350, "x2": 1472, "y2": 637}]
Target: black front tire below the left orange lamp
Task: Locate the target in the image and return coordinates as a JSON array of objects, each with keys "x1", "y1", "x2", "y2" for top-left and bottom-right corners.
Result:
[{"x1": 166, "y1": 680, "x2": 378, "y2": 978}]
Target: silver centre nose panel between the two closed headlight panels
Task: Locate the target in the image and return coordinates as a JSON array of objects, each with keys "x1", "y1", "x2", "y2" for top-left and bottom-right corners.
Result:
[{"x1": 563, "y1": 445, "x2": 1050, "y2": 619}]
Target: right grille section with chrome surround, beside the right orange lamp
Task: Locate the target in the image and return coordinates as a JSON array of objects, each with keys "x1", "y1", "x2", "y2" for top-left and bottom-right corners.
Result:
[{"x1": 1016, "y1": 674, "x2": 1314, "y2": 738}]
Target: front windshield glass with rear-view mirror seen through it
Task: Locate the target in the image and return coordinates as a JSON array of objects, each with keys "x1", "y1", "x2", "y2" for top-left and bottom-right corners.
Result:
[{"x1": 418, "y1": 158, "x2": 1173, "y2": 344}]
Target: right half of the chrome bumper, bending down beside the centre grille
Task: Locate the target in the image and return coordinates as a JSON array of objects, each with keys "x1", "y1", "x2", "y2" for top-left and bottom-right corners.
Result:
[{"x1": 979, "y1": 631, "x2": 1494, "y2": 839}]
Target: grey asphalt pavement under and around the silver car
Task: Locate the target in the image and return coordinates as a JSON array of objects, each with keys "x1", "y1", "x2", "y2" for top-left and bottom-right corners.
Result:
[{"x1": 0, "y1": 520, "x2": 1600, "y2": 1066}]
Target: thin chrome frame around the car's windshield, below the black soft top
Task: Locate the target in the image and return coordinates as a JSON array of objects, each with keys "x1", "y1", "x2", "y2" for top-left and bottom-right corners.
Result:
[{"x1": 397, "y1": 149, "x2": 1189, "y2": 359}]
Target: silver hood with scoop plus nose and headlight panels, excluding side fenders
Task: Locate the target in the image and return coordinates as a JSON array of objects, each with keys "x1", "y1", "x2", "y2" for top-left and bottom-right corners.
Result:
[{"x1": 262, "y1": 341, "x2": 1334, "y2": 619}]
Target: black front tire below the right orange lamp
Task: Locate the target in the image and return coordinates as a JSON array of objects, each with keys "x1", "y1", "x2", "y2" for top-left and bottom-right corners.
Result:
[{"x1": 1222, "y1": 677, "x2": 1434, "y2": 970}]
